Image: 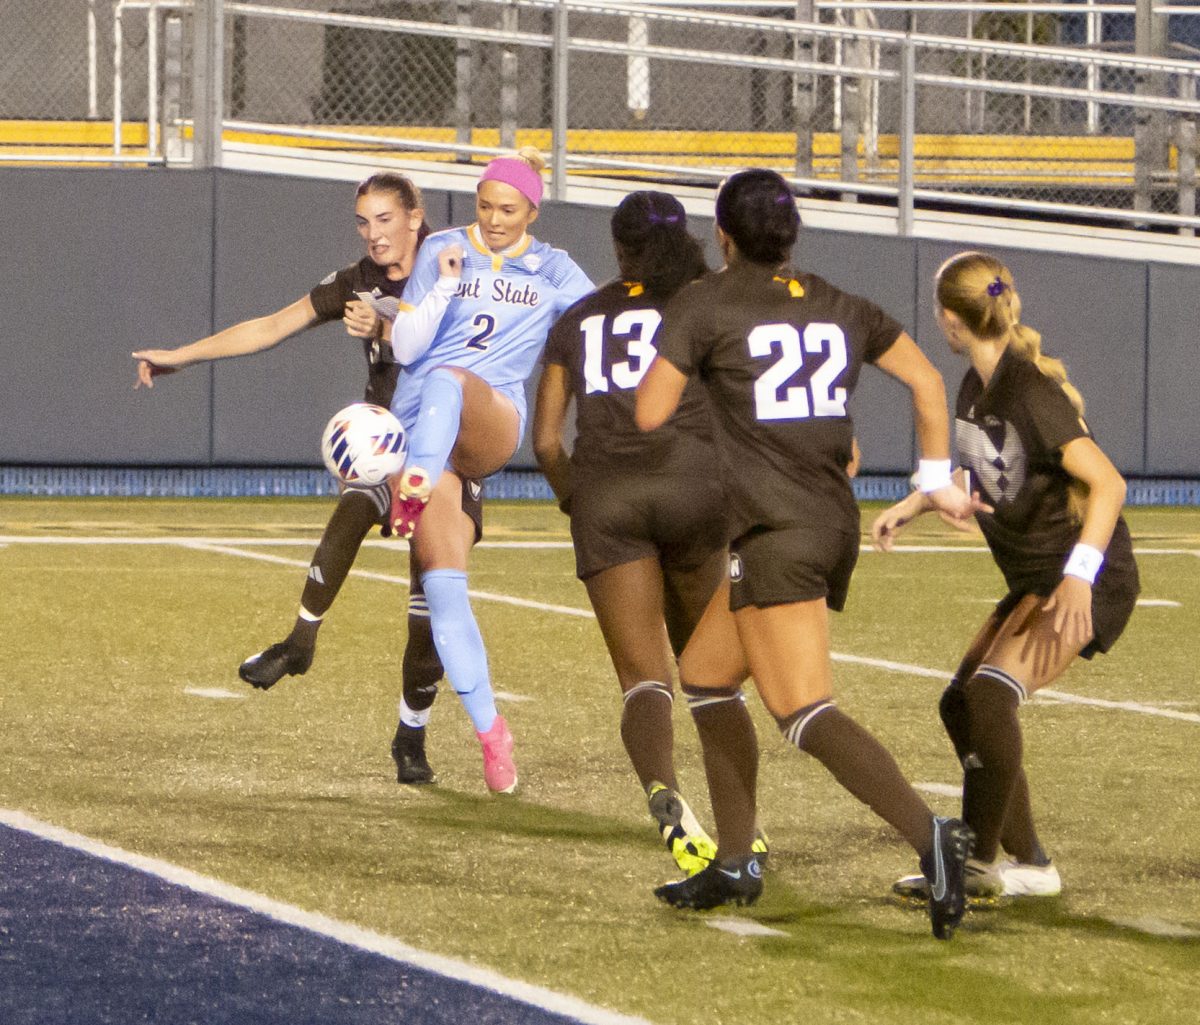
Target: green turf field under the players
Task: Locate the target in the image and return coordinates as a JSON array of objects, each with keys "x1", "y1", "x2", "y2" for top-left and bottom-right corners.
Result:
[{"x1": 0, "y1": 498, "x2": 1200, "y2": 1025}]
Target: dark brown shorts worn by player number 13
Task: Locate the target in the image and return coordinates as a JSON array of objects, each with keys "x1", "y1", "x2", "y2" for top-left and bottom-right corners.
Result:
[{"x1": 571, "y1": 473, "x2": 728, "y2": 580}]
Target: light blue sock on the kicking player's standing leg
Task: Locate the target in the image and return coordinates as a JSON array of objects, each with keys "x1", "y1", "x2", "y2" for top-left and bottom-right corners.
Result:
[{"x1": 421, "y1": 569, "x2": 496, "y2": 733}]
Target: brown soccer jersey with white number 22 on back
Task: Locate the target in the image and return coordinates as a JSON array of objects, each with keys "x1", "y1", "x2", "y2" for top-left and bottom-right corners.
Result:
[{"x1": 659, "y1": 263, "x2": 904, "y2": 537}]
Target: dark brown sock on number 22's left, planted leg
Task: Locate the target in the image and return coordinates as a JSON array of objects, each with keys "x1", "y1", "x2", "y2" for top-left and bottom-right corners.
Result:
[{"x1": 682, "y1": 684, "x2": 758, "y2": 859}]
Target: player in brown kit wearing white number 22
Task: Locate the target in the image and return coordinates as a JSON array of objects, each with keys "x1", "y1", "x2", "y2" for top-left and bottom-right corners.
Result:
[{"x1": 637, "y1": 169, "x2": 972, "y2": 939}]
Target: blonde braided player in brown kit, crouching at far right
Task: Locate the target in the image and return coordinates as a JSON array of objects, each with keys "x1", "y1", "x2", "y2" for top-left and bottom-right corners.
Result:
[{"x1": 871, "y1": 252, "x2": 1139, "y2": 898}]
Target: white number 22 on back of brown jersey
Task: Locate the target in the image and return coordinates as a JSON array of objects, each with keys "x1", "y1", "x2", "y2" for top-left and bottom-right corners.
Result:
[{"x1": 746, "y1": 320, "x2": 847, "y2": 420}]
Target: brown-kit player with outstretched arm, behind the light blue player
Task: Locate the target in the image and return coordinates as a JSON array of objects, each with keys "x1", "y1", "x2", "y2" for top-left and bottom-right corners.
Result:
[{"x1": 133, "y1": 172, "x2": 482, "y2": 783}]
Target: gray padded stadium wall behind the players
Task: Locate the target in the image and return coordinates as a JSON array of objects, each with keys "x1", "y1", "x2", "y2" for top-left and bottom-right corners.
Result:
[{"x1": 0, "y1": 168, "x2": 1200, "y2": 478}]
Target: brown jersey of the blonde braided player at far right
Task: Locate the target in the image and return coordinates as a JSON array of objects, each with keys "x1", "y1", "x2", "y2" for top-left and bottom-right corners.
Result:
[{"x1": 954, "y1": 348, "x2": 1136, "y2": 594}]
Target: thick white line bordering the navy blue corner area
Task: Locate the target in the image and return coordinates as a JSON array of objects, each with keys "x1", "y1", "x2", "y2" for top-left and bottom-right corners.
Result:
[{"x1": 0, "y1": 808, "x2": 650, "y2": 1025}]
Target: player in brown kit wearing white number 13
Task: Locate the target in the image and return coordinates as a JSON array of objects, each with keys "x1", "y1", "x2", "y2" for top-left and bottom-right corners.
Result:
[{"x1": 533, "y1": 191, "x2": 766, "y2": 875}]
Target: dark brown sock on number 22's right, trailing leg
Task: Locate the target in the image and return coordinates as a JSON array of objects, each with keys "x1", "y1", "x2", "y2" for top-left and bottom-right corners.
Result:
[{"x1": 779, "y1": 701, "x2": 934, "y2": 855}]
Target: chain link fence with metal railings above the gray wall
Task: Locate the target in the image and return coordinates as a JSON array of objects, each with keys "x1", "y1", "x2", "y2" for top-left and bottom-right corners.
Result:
[{"x1": 7, "y1": 0, "x2": 1200, "y2": 227}]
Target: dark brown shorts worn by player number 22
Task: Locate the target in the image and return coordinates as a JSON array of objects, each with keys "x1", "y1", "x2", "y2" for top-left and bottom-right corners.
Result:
[{"x1": 730, "y1": 527, "x2": 859, "y2": 612}]
